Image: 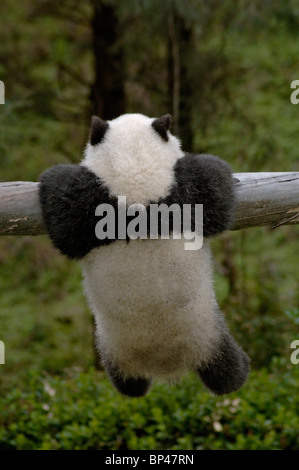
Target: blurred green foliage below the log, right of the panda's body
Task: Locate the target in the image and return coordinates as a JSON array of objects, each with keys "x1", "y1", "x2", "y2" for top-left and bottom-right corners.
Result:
[{"x1": 213, "y1": 227, "x2": 299, "y2": 367}]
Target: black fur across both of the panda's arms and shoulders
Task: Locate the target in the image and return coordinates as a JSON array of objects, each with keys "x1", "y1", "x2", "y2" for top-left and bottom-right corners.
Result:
[{"x1": 40, "y1": 154, "x2": 234, "y2": 259}]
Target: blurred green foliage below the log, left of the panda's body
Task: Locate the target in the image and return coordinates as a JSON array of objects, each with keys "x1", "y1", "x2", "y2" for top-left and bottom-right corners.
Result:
[{"x1": 0, "y1": 237, "x2": 94, "y2": 390}]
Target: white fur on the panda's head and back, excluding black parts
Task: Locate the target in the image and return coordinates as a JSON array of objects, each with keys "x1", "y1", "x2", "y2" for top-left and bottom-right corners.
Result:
[{"x1": 82, "y1": 114, "x2": 219, "y2": 380}]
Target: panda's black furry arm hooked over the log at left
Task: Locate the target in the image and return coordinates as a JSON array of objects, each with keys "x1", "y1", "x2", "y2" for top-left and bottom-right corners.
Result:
[{"x1": 39, "y1": 165, "x2": 114, "y2": 259}]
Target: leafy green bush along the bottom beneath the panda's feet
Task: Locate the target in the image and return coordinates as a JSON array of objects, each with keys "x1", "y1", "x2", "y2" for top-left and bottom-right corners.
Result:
[{"x1": 0, "y1": 366, "x2": 299, "y2": 450}]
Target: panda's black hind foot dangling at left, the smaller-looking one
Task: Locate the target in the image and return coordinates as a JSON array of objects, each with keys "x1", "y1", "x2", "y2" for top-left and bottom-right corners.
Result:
[{"x1": 105, "y1": 362, "x2": 152, "y2": 397}]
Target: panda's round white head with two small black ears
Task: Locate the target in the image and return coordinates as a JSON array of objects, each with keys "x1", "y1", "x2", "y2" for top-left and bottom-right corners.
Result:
[{"x1": 82, "y1": 114, "x2": 183, "y2": 205}]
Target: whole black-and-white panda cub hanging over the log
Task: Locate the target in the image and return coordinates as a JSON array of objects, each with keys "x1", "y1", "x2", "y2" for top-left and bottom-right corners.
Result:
[{"x1": 40, "y1": 114, "x2": 249, "y2": 397}]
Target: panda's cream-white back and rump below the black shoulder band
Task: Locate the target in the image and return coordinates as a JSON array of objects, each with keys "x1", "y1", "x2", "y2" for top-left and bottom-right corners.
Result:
[{"x1": 82, "y1": 239, "x2": 219, "y2": 380}]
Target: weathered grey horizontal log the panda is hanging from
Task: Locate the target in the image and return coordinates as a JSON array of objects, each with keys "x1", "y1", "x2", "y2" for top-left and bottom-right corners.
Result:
[{"x1": 0, "y1": 172, "x2": 299, "y2": 235}]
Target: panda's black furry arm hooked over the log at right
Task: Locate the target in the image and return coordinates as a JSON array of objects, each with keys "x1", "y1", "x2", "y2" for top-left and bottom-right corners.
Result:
[{"x1": 172, "y1": 154, "x2": 235, "y2": 237}]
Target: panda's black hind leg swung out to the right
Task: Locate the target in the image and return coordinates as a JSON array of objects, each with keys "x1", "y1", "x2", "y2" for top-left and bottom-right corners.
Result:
[{"x1": 196, "y1": 330, "x2": 249, "y2": 395}]
